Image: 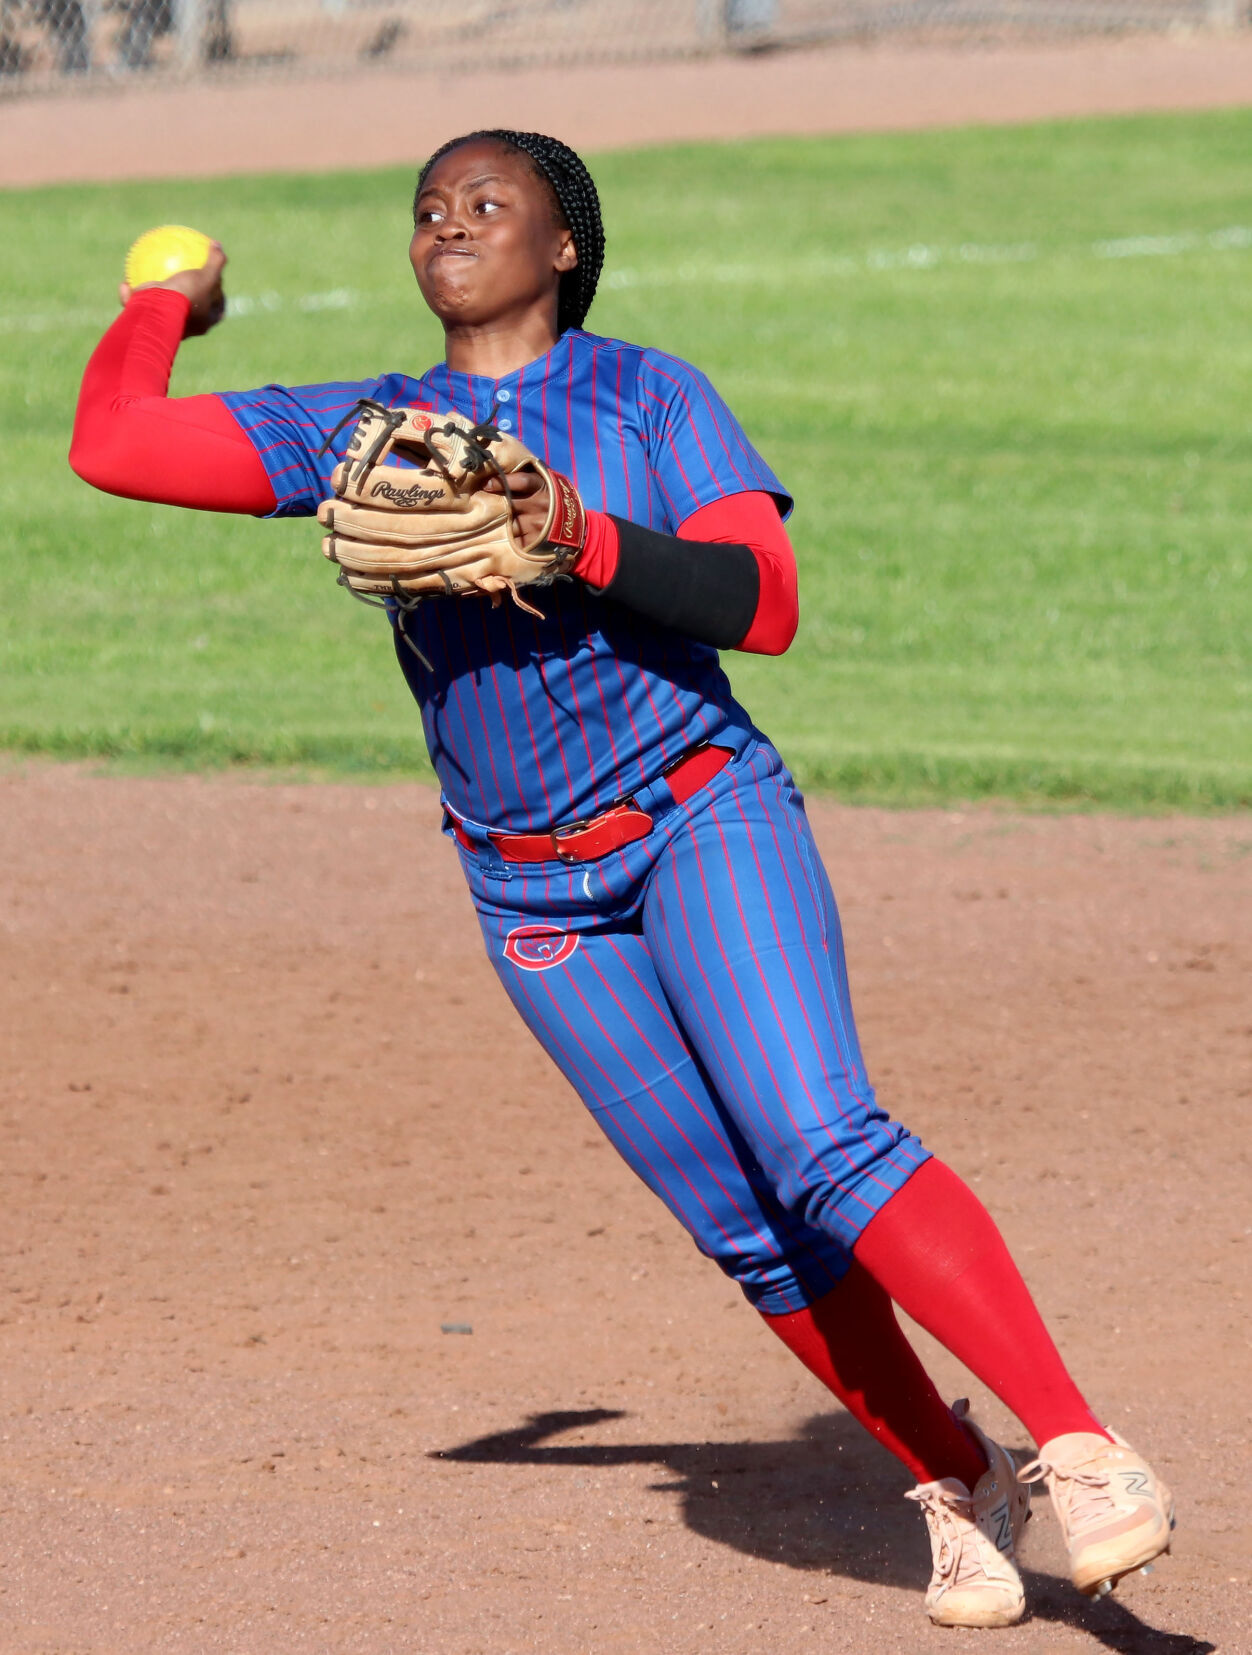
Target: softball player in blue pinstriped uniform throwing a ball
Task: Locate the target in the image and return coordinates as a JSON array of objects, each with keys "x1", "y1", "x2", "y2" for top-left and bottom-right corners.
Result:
[{"x1": 71, "y1": 131, "x2": 1173, "y2": 1625}]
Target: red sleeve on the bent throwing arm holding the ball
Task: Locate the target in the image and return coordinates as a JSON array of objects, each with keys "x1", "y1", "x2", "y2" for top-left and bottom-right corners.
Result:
[{"x1": 70, "y1": 288, "x2": 275, "y2": 516}]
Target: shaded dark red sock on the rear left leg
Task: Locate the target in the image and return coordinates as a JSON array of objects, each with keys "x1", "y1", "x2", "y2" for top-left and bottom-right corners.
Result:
[{"x1": 765, "y1": 1263, "x2": 987, "y2": 1488}]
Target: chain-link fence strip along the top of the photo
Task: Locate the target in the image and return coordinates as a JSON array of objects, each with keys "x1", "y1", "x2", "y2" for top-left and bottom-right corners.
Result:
[{"x1": 0, "y1": 0, "x2": 1252, "y2": 96}]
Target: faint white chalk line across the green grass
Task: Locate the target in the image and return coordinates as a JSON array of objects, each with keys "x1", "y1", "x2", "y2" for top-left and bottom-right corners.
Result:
[{"x1": 0, "y1": 225, "x2": 1252, "y2": 333}]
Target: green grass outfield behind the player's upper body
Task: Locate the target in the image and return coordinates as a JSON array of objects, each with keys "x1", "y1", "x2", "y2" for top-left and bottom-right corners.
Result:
[{"x1": 0, "y1": 111, "x2": 1252, "y2": 809}]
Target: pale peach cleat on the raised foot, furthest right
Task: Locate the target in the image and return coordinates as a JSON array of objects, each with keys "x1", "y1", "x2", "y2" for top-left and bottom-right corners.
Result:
[{"x1": 1017, "y1": 1432, "x2": 1174, "y2": 1597}]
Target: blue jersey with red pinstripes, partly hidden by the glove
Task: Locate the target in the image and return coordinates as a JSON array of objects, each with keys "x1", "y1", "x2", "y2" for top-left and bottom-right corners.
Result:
[{"x1": 224, "y1": 329, "x2": 790, "y2": 832}]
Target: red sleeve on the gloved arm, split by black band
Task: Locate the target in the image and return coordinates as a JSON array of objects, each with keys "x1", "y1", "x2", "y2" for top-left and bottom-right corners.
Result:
[{"x1": 573, "y1": 490, "x2": 800, "y2": 655}]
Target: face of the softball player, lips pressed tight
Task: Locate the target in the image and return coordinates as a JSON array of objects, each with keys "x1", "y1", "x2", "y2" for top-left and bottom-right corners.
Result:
[{"x1": 409, "y1": 142, "x2": 578, "y2": 338}]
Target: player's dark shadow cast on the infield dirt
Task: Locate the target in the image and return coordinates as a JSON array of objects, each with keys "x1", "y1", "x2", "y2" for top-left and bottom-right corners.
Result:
[{"x1": 431, "y1": 1408, "x2": 1216, "y2": 1655}]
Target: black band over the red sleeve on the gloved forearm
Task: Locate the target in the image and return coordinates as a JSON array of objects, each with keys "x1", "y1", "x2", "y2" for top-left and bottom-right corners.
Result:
[{"x1": 598, "y1": 516, "x2": 760, "y2": 649}]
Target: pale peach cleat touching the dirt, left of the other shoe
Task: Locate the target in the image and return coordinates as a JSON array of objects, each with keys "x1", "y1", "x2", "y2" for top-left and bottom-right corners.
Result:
[{"x1": 904, "y1": 1400, "x2": 1030, "y2": 1627}]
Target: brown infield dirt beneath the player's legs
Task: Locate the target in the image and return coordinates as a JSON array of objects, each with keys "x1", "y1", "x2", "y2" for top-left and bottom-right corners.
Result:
[{"x1": 0, "y1": 765, "x2": 1252, "y2": 1655}]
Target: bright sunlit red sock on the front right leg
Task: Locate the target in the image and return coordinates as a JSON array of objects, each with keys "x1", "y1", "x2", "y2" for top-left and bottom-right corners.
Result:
[{"x1": 853, "y1": 1160, "x2": 1108, "y2": 1443}]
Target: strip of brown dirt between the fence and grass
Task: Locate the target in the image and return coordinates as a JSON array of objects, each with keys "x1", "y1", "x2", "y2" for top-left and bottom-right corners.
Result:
[{"x1": 0, "y1": 31, "x2": 1252, "y2": 185}]
